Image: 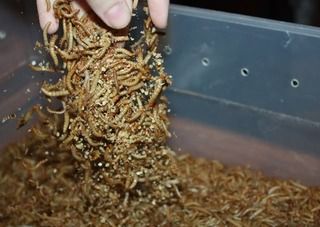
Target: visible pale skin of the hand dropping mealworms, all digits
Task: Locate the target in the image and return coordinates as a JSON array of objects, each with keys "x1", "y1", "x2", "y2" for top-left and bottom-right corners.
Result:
[{"x1": 37, "y1": 0, "x2": 169, "y2": 34}]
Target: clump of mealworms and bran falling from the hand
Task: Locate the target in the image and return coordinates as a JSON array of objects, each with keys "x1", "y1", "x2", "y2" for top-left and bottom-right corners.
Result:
[{"x1": 30, "y1": 0, "x2": 179, "y2": 205}]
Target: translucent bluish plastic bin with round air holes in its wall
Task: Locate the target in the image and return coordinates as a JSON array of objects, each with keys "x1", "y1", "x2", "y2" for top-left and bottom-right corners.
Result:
[{"x1": 0, "y1": 1, "x2": 320, "y2": 185}]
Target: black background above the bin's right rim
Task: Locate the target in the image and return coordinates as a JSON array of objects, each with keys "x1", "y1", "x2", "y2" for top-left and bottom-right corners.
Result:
[{"x1": 171, "y1": 0, "x2": 320, "y2": 26}]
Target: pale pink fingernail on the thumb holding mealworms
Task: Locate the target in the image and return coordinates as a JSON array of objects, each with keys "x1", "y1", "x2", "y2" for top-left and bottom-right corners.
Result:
[{"x1": 103, "y1": 1, "x2": 131, "y2": 29}]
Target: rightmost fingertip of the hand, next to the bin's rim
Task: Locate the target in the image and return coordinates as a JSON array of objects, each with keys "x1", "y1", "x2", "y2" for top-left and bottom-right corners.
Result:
[{"x1": 148, "y1": 0, "x2": 169, "y2": 28}]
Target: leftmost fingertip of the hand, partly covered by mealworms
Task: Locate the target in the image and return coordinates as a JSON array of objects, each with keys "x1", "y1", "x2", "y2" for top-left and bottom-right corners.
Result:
[{"x1": 37, "y1": 0, "x2": 59, "y2": 34}]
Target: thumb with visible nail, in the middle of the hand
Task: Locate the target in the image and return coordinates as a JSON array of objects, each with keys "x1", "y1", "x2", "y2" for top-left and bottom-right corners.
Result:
[{"x1": 87, "y1": 0, "x2": 132, "y2": 29}]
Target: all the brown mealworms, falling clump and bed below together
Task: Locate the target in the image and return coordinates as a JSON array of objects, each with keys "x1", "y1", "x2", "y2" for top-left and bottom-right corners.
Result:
[{"x1": 0, "y1": 0, "x2": 320, "y2": 226}]
